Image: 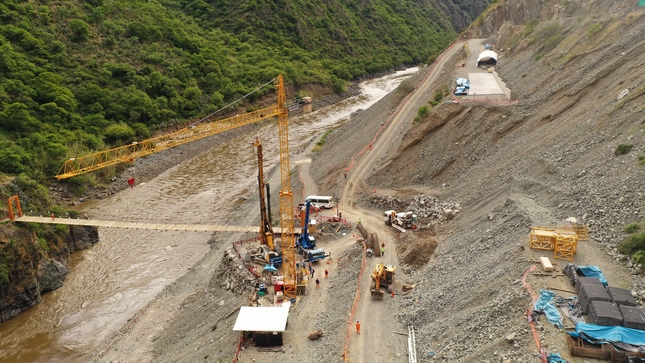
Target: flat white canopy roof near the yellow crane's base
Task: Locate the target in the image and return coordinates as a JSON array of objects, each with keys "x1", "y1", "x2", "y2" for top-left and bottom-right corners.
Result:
[{"x1": 233, "y1": 301, "x2": 291, "y2": 332}]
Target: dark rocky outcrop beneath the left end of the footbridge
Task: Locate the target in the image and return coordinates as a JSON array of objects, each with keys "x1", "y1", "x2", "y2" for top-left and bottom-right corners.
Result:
[{"x1": 0, "y1": 224, "x2": 98, "y2": 321}]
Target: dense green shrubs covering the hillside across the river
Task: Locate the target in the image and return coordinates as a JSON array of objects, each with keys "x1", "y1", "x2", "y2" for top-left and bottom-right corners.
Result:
[{"x1": 0, "y1": 0, "x2": 472, "y2": 212}]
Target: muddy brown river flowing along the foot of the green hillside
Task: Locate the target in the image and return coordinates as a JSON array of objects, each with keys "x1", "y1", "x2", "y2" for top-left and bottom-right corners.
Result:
[{"x1": 0, "y1": 68, "x2": 418, "y2": 363}]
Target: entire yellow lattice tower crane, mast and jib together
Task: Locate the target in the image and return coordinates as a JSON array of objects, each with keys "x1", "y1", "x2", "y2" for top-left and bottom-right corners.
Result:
[{"x1": 56, "y1": 75, "x2": 296, "y2": 298}]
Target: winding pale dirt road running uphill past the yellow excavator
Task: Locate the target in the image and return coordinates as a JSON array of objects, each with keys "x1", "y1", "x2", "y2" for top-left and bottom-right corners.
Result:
[{"x1": 339, "y1": 43, "x2": 462, "y2": 362}]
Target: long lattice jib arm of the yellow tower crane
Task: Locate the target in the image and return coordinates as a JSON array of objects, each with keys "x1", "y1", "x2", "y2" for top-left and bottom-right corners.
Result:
[{"x1": 56, "y1": 104, "x2": 286, "y2": 180}]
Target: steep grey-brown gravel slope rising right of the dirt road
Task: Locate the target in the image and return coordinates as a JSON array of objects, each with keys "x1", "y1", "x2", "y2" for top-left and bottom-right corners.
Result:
[{"x1": 313, "y1": 1, "x2": 645, "y2": 362}]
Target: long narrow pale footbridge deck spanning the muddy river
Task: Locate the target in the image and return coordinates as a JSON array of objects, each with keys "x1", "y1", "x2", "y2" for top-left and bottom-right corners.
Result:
[{"x1": 15, "y1": 216, "x2": 301, "y2": 234}]
